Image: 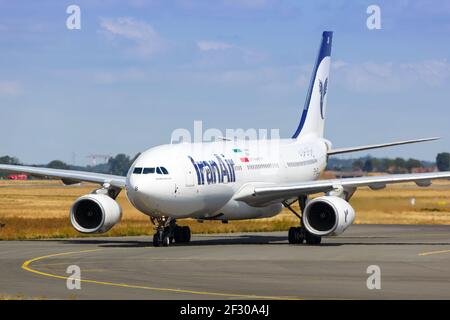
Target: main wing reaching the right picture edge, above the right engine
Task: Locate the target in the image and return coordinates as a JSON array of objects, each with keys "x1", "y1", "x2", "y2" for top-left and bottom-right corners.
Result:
[{"x1": 234, "y1": 171, "x2": 450, "y2": 206}]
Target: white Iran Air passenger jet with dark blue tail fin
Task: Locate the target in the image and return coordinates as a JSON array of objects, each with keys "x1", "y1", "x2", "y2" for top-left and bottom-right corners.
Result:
[{"x1": 0, "y1": 31, "x2": 450, "y2": 247}]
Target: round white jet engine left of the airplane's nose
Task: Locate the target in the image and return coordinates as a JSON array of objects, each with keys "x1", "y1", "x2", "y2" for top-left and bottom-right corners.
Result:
[{"x1": 70, "y1": 194, "x2": 122, "y2": 233}]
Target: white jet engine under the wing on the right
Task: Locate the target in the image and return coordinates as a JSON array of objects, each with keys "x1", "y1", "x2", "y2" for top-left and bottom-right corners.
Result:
[{"x1": 303, "y1": 196, "x2": 355, "y2": 236}]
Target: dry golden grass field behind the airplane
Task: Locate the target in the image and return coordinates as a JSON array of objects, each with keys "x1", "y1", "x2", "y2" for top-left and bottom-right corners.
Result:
[{"x1": 0, "y1": 180, "x2": 450, "y2": 240}]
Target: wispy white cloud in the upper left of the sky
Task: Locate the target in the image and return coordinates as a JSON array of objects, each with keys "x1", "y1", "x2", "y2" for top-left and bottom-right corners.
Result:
[{"x1": 100, "y1": 17, "x2": 166, "y2": 56}]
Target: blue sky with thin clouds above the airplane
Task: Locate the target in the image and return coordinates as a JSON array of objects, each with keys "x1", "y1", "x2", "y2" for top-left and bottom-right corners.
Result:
[{"x1": 0, "y1": 0, "x2": 450, "y2": 165}]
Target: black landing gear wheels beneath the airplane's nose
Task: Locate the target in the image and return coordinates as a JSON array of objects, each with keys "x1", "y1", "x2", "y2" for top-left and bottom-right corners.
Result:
[{"x1": 150, "y1": 217, "x2": 191, "y2": 247}]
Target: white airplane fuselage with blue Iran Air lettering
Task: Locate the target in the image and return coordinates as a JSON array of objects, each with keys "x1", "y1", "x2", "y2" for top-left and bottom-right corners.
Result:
[{"x1": 126, "y1": 137, "x2": 330, "y2": 220}]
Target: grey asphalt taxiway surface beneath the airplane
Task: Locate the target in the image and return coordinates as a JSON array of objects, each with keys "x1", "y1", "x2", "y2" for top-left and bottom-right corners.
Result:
[{"x1": 0, "y1": 225, "x2": 450, "y2": 299}]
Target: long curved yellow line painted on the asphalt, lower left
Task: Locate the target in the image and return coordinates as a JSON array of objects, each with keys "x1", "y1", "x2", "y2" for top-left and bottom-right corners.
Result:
[{"x1": 22, "y1": 249, "x2": 304, "y2": 300}]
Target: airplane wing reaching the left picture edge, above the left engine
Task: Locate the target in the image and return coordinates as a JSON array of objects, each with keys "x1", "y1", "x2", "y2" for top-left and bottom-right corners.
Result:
[{"x1": 0, "y1": 164, "x2": 126, "y2": 188}]
